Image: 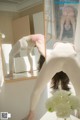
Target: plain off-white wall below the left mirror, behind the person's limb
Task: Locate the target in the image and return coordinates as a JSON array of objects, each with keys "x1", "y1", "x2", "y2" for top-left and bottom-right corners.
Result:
[{"x1": 0, "y1": 80, "x2": 47, "y2": 120}]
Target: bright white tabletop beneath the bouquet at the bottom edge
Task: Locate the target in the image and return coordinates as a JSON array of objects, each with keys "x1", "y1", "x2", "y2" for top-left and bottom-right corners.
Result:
[{"x1": 40, "y1": 112, "x2": 80, "y2": 120}]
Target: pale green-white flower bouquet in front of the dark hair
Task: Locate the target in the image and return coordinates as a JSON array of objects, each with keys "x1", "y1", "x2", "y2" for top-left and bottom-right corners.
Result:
[{"x1": 46, "y1": 90, "x2": 80, "y2": 120}]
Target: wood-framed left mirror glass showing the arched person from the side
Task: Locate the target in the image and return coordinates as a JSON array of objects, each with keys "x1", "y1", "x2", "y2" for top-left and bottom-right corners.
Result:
[{"x1": 0, "y1": 0, "x2": 45, "y2": 80}]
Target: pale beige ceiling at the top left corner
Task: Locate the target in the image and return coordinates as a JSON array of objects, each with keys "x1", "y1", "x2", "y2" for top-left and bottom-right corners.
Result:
[{"x1": 0, "y1": 0, "x2": 43, "y2": 12}]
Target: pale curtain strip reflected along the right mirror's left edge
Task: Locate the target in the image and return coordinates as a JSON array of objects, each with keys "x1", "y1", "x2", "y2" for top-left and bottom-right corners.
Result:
[{"x1": 44, "y1": 0, "x2": 56, "y2": 42}]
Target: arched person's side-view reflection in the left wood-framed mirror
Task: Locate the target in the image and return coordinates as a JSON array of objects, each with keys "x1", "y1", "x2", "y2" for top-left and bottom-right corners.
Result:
[{"x1": 7, "y1": 34, "x2": 45, "y2": 77}]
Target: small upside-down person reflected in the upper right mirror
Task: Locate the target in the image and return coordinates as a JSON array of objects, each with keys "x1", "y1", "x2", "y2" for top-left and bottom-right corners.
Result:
[{"x1": 59, "y1": 6, "x2": 76, "y2": 40}]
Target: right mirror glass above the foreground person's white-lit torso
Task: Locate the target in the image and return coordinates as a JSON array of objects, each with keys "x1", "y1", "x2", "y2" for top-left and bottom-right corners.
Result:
[{"x1": 44, "y1": 0, "x2": 79, "y2": 54}]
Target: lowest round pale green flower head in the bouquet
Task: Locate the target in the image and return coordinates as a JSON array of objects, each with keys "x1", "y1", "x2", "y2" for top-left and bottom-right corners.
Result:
[{"x1": 56, "y1": 103, "x2": 72, "y2": 118}]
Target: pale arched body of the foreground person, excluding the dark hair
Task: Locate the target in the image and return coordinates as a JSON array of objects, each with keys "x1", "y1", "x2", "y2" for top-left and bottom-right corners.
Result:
[{"x1": 30, "y1": 43, "x2": 80, "y2": 111}]
